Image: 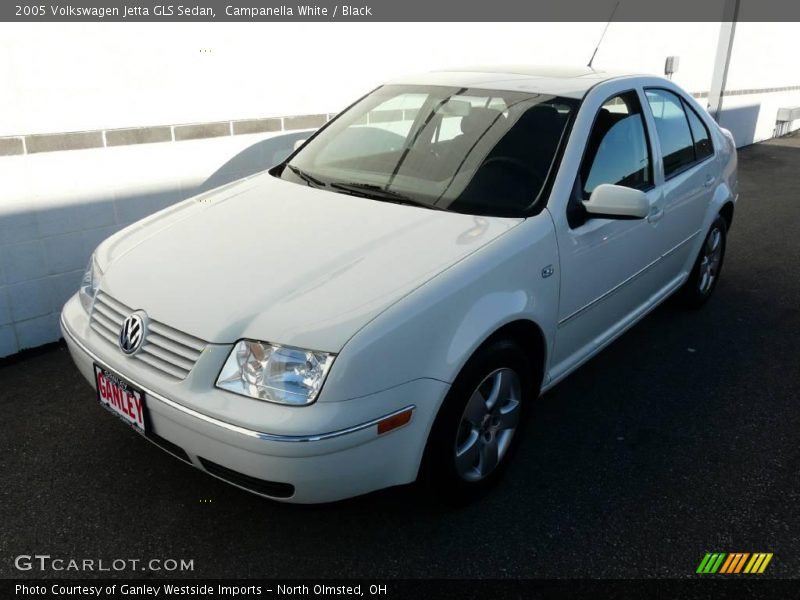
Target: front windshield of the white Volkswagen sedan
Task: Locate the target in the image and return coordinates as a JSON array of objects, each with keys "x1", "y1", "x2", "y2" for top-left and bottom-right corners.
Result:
[{"x1": 273, "y1": 85, "x2": 577, "y2": 216}]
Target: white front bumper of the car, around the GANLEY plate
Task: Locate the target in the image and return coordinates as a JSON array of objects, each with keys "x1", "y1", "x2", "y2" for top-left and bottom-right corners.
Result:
[{"x1": 61, "y1": 296, "x2": 448, "y2": 503}]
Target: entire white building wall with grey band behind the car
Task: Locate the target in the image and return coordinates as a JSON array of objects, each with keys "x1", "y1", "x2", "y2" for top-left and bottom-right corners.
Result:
[{"x1": 0, "y1": 23, "x2": 800, "y2": 357}]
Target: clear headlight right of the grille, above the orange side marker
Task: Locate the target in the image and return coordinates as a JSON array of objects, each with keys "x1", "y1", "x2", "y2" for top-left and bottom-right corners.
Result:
[{"x1": 217, "y1": 340, "x2": 334, "y2": 406}]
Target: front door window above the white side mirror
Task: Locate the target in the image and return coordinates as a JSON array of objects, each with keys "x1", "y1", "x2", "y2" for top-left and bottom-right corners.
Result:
[{"x1": 581, "y1": 92, "x2": 652, "y2": 198}]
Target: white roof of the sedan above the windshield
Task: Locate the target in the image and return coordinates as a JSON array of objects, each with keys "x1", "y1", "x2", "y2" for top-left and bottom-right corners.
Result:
[{"x1": 389, "y1": 65, "x2": 640, "y2": 98}]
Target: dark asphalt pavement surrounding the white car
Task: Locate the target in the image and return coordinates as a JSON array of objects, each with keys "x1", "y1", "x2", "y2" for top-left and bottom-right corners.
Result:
[{"x1": 0, "y1": 136, "x2": 800, "y2": 578}]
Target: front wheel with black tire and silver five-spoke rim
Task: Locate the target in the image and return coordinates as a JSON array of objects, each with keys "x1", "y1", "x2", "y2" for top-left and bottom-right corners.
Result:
[{"x1": 420, "y1": 339, "x2": 539, "y2": 504}]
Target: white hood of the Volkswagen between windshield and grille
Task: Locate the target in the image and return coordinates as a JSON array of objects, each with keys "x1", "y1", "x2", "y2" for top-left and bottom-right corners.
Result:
[{"x1": 96, "y1": 174, "x2": 522, "y2": 352}]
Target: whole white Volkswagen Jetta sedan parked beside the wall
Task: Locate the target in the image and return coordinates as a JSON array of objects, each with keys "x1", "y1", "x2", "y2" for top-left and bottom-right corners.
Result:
[{"x1": 61, "y1": 68, "x2": 737, "y2": 503}]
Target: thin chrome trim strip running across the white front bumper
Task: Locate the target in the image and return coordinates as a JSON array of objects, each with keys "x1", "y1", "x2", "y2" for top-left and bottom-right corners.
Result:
[{"x1": 61, "y1": 314, "x2": 417, "y2": 442}]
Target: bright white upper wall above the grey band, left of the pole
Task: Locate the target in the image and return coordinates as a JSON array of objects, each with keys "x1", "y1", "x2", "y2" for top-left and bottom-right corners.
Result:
[{"x1": 0, "y1": 22, "x2": 724, "y2": 136}]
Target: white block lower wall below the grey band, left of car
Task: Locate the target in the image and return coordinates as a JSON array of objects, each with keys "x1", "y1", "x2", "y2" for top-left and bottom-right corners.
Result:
[{"x1": 0, "y1": 131, "x2": 308, "y2": 357}]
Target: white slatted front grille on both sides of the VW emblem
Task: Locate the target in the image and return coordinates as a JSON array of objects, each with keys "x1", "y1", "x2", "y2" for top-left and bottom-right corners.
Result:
[{"x1": 91, "y1": 292, "x2": 206, "y2": 379}]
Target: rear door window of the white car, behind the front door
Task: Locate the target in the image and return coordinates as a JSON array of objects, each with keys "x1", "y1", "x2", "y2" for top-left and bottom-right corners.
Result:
[{"x1": 646, "y1": 90, "x2": 694, "y2": 177}]
